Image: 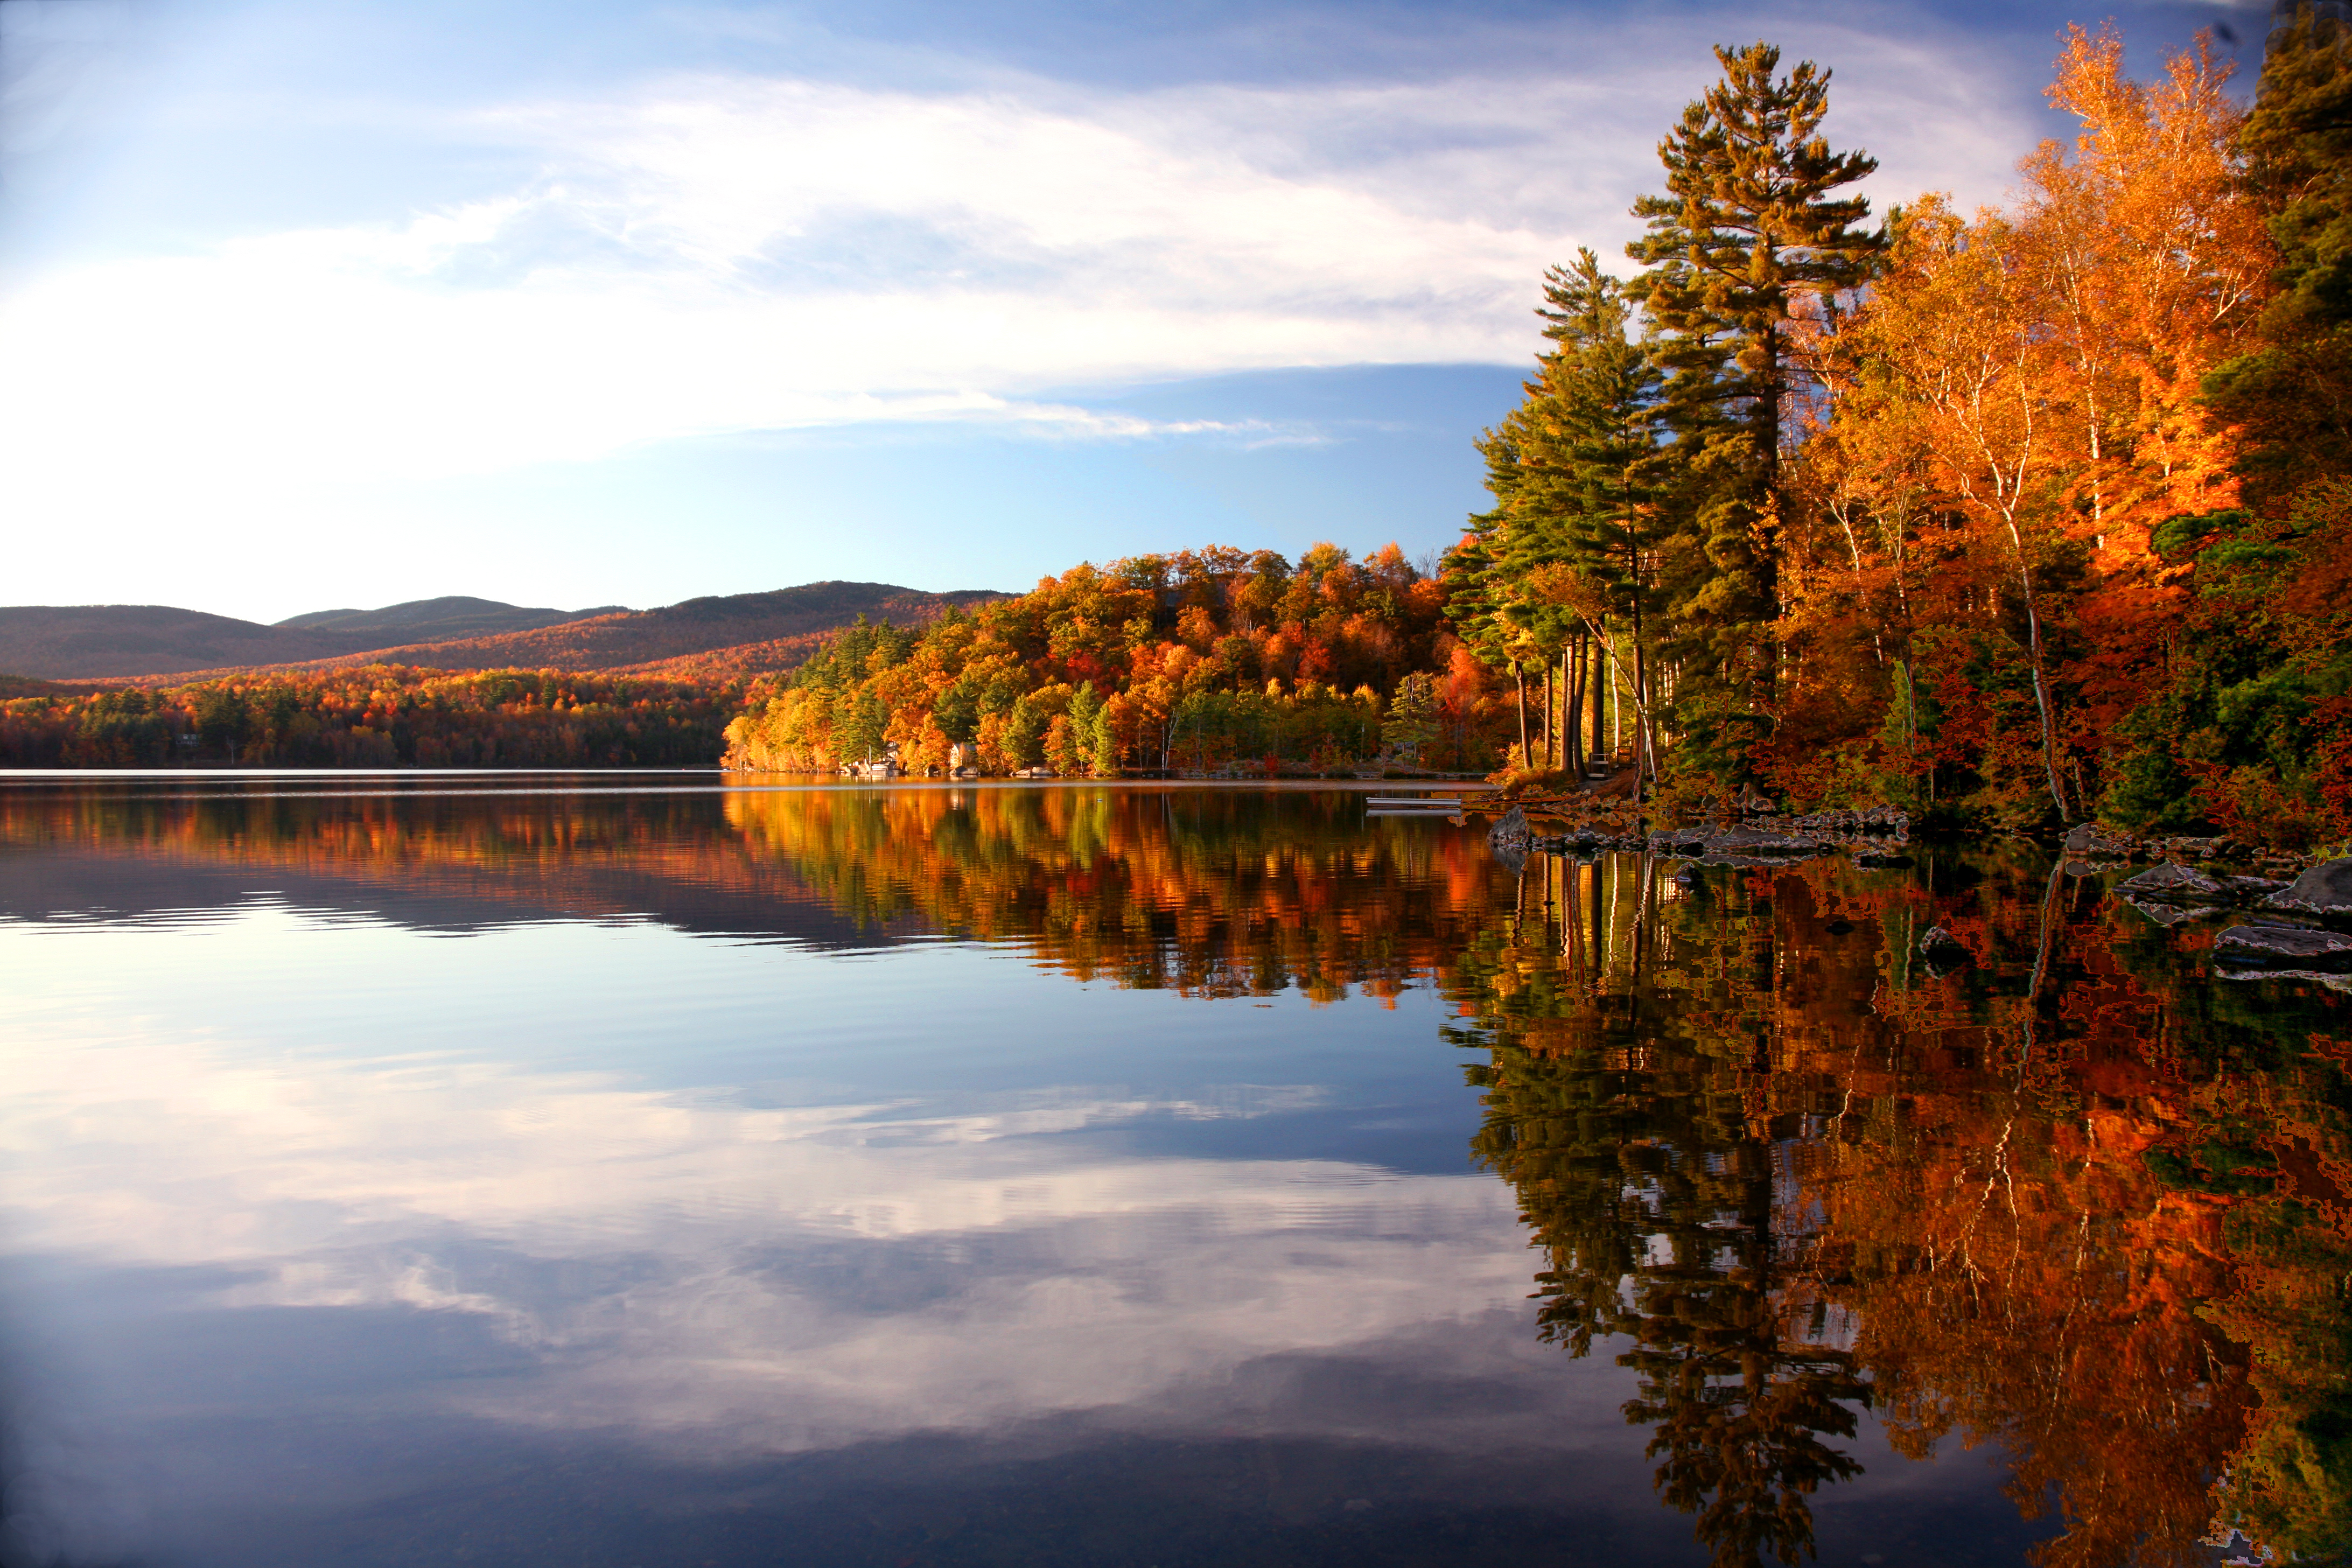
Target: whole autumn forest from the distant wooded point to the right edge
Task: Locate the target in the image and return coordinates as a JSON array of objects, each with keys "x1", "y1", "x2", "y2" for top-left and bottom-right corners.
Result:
[{"x1": 729, "y1": 17, "x2": 2352, "y2": 846}]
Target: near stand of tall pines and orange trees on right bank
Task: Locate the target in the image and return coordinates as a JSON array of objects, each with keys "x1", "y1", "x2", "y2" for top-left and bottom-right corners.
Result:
[{"x1": 1453, "y1": 17, "x2": 2352, "y2": 842}]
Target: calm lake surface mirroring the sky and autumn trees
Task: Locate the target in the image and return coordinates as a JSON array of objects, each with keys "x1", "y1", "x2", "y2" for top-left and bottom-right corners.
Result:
[{"x1": 0, "y1": 773, "x2": 2352, "y2": 1568}]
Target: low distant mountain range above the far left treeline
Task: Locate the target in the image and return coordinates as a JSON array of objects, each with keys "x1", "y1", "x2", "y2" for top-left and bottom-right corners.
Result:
[{"x1": 0, "y1": 580, "x2": 1009, "y2": 682}]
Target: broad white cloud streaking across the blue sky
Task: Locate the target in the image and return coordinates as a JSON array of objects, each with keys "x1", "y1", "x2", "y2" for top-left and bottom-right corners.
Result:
[{"x1": 0, "y1": 12, "x2": 2027, "y2": 541}]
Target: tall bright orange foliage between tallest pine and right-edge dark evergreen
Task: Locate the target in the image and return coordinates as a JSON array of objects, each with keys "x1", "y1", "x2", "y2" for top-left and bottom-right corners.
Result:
[{"x1": 1776, "y1": 28, "x2": 2272, "y2": 818}]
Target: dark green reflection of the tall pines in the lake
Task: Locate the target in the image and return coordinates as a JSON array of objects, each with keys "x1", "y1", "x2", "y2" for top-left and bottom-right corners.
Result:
[{"x1": 1453, "y1": 872, "x2": 1867, "y2": 1568}]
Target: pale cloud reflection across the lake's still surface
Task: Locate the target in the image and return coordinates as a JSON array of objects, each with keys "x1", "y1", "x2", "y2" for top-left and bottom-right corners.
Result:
[{"x1": 0, "y1": 1027, "x2": 1527, "y2": 1448}]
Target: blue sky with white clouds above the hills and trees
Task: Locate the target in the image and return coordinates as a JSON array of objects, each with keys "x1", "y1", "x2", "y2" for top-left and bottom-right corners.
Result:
[{"x1": 0, "y1": 0, "x2": 2267, "y2": 621}]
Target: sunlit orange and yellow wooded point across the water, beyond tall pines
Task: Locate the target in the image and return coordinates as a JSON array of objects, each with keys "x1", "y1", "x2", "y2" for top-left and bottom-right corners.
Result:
[{"x1": 727, "y1": 545, "x2": 1503, "y2": 773}]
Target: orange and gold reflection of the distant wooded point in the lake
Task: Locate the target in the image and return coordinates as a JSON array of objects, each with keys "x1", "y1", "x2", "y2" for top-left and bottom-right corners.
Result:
[{"x1": 727, "y1": 788, "x2": 1496, "y2": 1002}]
